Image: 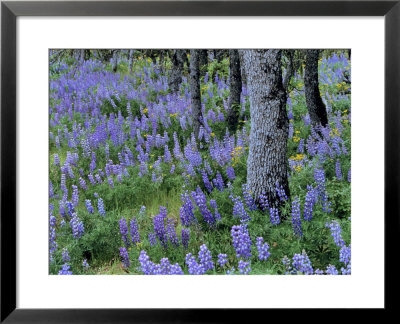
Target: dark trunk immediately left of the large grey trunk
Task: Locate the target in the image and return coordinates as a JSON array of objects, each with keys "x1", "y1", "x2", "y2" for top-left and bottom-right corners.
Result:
[{"x1": 227, "y1": 50, "x2": 242, "y2": 133}]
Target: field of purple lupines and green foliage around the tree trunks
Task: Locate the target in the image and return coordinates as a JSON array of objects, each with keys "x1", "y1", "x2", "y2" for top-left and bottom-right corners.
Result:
[{"x1": 49, "y1": 50, "x2": 351, "y2": 275}]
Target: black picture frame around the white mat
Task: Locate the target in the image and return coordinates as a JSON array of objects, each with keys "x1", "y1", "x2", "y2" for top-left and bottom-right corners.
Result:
[{"x1": 0, "y1": 0, "x2": 400, "y2": 323}]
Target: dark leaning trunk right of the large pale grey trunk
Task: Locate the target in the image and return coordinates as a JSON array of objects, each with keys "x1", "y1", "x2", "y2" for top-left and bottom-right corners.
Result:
[{"x1": 304, "y1": 50, "x2": 328, "y2": 126}]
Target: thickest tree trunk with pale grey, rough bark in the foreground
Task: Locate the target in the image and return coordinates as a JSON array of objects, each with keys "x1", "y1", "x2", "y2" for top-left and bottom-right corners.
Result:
[{"x1": 239, "y1": 50, "x2": 290, "y2": 208}]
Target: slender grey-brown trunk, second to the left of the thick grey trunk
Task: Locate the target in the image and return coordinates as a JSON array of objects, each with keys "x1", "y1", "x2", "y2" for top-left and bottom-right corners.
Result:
[{"x1": 190, "y1": 50, "x2": 202, "y2": 138}]
